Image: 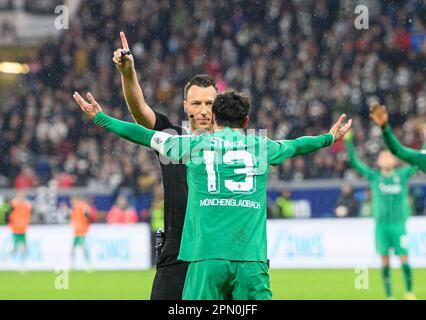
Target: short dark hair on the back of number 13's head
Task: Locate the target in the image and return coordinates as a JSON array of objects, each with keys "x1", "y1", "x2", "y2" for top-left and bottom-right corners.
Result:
[{"x1": 212, "y1": 90, "x2": 250, "y2": 128}]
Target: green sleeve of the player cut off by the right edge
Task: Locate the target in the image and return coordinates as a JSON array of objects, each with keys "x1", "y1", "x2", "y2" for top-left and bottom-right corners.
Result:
[{"x1": 382, "y1": 125, "x2": 426, "y2": 173}]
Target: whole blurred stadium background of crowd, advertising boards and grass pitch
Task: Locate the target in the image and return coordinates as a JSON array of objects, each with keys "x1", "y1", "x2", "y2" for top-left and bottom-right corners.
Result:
[{"x1": 0, "y1": 0, "x2": 426, "y2": 299}]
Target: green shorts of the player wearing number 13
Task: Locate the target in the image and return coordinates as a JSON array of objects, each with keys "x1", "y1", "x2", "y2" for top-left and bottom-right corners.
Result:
[{"x1": 182, "y1": 259, "x2": 272, "y2": 300}]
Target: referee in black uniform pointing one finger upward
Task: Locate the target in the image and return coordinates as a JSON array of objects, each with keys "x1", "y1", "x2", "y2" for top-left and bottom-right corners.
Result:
[{"x1": 113, "y1": 32, "x2": 217, "y2": 300}]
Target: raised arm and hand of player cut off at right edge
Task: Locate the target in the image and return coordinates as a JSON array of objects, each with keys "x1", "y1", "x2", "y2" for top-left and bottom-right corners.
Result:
[{"x1": 370, "y1": 102, "x2": 426, "y2": 173}]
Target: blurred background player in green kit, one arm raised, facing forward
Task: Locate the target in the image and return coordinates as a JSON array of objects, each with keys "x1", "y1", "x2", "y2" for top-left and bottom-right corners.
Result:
[{"x1": 344, "y1": 131, "x2": 417, "y2": 299}]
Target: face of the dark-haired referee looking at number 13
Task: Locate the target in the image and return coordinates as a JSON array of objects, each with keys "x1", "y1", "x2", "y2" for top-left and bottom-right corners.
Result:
[{"x1": 183, "y1": 85, "x2": 217, "y2": 131}]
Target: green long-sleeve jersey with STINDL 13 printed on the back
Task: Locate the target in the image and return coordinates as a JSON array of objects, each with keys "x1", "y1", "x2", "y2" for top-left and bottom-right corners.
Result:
[{"x1": 95, "y1": 113, "x2": 333, "y2": 262}]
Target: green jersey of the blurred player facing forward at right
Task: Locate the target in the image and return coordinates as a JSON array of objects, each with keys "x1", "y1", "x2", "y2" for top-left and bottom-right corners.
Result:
[{"x1": 345, "y1": 138, "x2": 417, "y2": 224}]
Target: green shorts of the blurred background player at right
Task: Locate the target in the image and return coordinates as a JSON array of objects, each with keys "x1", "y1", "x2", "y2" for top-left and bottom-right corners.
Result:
[{"x1": 376, "y1": 224, "x2": 408, "y2": 256}]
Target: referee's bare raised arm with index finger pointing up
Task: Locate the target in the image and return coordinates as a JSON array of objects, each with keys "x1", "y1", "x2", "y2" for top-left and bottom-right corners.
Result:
[{"x1": 112, "y1": 32, "x2": 156, "y2": 129}]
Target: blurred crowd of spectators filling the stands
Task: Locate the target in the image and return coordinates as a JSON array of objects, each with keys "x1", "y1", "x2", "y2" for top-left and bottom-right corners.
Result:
[{"x1": 0, "y1": 0, "x2": 426, "y2": 220}]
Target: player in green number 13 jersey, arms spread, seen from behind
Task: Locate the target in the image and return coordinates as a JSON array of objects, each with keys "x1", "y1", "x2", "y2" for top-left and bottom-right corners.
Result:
[{"x1": 74, "y1": 91, "x2": 351, "y2": 300}]
